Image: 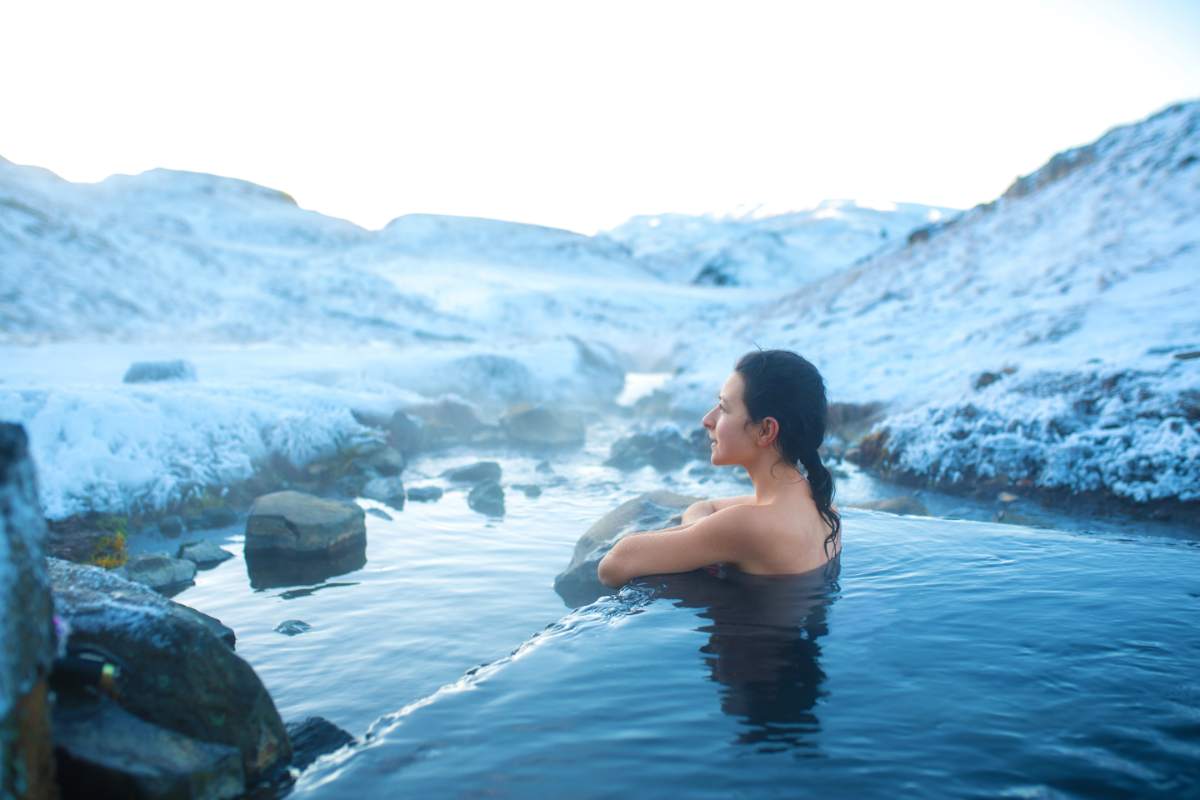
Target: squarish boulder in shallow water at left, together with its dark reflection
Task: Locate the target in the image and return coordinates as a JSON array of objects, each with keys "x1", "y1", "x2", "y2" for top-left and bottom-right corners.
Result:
[{"x1": 246, "y1": 491, "x2": 367, "y2": 589}]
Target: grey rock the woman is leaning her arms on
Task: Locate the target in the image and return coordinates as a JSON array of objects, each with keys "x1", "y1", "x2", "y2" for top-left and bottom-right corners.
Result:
[{"x1": 554, "y1": 491, "x2": 700, "y2": 608}]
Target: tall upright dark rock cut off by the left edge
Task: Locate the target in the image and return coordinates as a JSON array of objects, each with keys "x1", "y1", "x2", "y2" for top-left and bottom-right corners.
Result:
[{"x1": 0, "y1": 423, "x2": 56, "y2": 798}]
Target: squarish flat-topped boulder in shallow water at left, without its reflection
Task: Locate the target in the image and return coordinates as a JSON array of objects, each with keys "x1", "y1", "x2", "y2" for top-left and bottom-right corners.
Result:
[{"x1": 246, "y1": 491, "x2": 367, "y2": 558}]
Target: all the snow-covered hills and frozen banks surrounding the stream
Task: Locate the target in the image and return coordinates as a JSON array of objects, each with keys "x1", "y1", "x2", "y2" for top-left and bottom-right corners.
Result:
[{"x1": 0, "y1": 103, "x2": 1200, "y2": 518}]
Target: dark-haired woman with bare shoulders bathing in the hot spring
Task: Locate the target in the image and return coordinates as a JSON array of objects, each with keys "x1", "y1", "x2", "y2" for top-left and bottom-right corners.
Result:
[{"x1": 598, "y1": 350, "x2": 841, "y2": 587}]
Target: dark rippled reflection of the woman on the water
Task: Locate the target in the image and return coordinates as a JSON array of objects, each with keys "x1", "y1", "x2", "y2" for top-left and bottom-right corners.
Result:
[{"x1": 644, "y1": 557, "x2": 841, "y2": 754}]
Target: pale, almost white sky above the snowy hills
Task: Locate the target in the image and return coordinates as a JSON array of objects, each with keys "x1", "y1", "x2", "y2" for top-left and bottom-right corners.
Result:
[{"x1": 0, "y1": 0, "x2": 1200, "y2": 233}]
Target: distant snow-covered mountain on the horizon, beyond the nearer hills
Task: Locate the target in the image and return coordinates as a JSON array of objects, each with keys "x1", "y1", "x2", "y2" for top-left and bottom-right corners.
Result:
[{"x1": 606, "y1": 200, "x2": 958, "y2": 288}]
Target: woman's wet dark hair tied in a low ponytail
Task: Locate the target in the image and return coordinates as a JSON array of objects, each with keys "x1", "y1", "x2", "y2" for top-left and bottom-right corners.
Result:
[{"x1": 734, "y1": 350, "x2": 841, "y2": 558}]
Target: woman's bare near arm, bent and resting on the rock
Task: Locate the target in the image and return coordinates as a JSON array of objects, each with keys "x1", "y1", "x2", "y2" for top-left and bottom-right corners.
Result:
[{"x1": 596, "y1": 506, "x2": 751, "y2": 587}]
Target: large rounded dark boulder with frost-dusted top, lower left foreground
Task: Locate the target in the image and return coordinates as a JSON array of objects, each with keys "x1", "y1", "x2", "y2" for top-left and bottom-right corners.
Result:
[{"x1": 49, "y1": 559, "x2": 292, "y2": 786}]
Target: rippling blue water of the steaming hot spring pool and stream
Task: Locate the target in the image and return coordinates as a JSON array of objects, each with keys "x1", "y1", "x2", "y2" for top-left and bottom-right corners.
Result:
[{"x1": 176, "y1": 434, "x2": 1200, "y2": 798}]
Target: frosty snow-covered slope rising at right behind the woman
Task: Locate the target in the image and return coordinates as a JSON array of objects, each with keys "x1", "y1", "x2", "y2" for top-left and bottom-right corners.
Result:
[{"x1": 677, "y1": 102, "x2": 1200, "y2": 501}]
